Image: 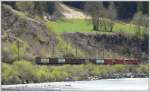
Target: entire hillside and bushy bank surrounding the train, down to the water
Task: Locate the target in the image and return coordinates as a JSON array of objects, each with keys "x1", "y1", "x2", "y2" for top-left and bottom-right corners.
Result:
[{"x1": 1, "y1": 2, "x2": 149, "y2": 85}]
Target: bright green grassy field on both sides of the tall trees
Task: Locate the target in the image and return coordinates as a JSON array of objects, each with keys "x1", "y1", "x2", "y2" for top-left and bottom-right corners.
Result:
[{"x1": 46, "y1": 19, "x2": 145, "y2": 35}]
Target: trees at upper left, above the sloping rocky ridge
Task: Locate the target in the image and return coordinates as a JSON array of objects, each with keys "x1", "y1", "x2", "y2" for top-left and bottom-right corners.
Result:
[{"x1": 14, "y1": 1, "x2": 55, "y2": 18}]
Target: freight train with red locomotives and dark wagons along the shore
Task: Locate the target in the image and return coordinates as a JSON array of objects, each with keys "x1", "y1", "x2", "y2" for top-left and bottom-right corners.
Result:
[{"x1": 35, "y1": 57, "x2": 139, "y2": 65}]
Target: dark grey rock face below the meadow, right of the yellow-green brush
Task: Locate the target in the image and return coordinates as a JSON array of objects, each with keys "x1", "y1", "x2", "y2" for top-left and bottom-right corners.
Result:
[{"x1": 64, "y1": 32, "x2": 148, "y2": 60}]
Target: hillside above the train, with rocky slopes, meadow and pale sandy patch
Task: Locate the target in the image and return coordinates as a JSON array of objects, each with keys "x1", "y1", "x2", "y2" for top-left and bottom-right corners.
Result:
[{"x1": 2, "y1": 3, "x2": 148, "y2": 62}]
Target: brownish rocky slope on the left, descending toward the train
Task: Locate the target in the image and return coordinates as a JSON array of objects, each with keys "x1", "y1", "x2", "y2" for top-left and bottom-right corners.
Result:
[{"x1": 2, "y1": 5, "x2": 56, "y2": 62}]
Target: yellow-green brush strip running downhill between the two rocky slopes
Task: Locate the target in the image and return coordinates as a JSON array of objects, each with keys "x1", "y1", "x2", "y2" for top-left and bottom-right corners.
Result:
[{"x1": 45, "y1": 21, "x2": 87, "y2": 57}]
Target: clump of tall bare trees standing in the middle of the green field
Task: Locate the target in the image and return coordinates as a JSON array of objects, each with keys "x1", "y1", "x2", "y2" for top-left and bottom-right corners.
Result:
[{"x1": 85, "y1": 2, "x2": 117, "y2": 32}]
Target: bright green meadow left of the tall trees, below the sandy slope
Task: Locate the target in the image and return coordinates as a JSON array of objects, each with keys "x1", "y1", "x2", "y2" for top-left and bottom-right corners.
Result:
[{"x1": 46, "y1": 19, "x2": 92, "y2": 33}]
